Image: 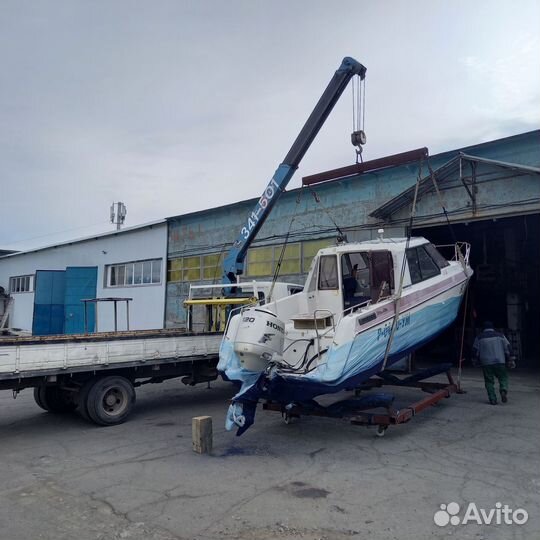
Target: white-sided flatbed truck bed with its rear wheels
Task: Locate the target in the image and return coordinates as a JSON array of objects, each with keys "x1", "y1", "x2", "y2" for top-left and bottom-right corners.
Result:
[{"x1": 0, "y1": 329, "x2": 222, "y2": 425}]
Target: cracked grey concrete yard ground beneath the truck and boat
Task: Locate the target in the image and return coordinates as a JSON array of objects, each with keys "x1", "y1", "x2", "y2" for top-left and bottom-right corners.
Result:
[{"x1": 0, "y1": 370, "x2": 540, "y2": 540}]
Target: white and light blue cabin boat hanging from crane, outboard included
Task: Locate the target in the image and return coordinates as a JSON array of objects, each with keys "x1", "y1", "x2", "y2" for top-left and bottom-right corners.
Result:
[{"x1": 218, "y1": 238, "x2": 472, "y2": 435}]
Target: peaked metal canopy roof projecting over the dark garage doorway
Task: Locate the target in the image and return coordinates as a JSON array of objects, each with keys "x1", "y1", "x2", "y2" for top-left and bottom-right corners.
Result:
[{"x1": 369, "y1": 153, "x2": 540, "y2": 220}]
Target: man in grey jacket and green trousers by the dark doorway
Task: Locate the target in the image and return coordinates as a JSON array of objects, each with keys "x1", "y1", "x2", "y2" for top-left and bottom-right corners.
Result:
[{"x1": 472, "y1": 321, "x2": 510, "y2": 405}]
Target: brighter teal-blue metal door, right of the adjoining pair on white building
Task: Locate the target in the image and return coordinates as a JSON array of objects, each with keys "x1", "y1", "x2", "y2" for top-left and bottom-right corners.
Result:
[{"x1": 64, "y1": 266, "x2": 97, "y2": 334}]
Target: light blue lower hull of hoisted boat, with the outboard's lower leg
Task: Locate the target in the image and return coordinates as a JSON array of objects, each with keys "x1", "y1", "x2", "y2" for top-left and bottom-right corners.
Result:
[{"x1": 218, "y1": 273, "x2": 468, "y2": 435}]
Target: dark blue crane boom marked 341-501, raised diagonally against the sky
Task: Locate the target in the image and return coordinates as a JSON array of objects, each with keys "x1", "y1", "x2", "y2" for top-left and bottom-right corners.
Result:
[{"x1": 223, "y1": 57, "x2": 366, "y2": 283}]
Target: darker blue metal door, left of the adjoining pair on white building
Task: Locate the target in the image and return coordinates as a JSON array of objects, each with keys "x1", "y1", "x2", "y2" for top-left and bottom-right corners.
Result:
[{"x1": 32, "y1": 270, "x2": 66, "y2": 336}]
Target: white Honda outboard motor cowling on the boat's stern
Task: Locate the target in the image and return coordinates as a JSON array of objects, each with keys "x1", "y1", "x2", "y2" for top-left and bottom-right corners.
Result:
[{"x1": 234, "y1": 308, "x2": 285, "y2": 371}]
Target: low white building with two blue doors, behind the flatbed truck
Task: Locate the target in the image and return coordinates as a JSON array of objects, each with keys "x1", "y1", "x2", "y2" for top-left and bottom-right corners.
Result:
[{"x1": 0, "y1": 220, "x2": 167, "y2": 335}]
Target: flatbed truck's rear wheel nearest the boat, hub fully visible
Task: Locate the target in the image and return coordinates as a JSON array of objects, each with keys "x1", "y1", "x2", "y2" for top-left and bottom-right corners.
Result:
[{"x1": 83, "y1": 375, "x2": 135, "y2": 426}]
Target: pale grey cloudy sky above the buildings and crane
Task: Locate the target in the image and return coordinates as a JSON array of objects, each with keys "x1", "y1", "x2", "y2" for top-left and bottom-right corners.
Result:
[{"x1": 0, "y1": 0, "x2": 540, "y2": 249}]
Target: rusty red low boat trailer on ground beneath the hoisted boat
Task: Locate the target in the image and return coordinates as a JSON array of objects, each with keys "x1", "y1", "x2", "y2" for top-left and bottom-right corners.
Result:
[{"x1": 263, "y1": 363, "x2": 464, "y2": 437}]
